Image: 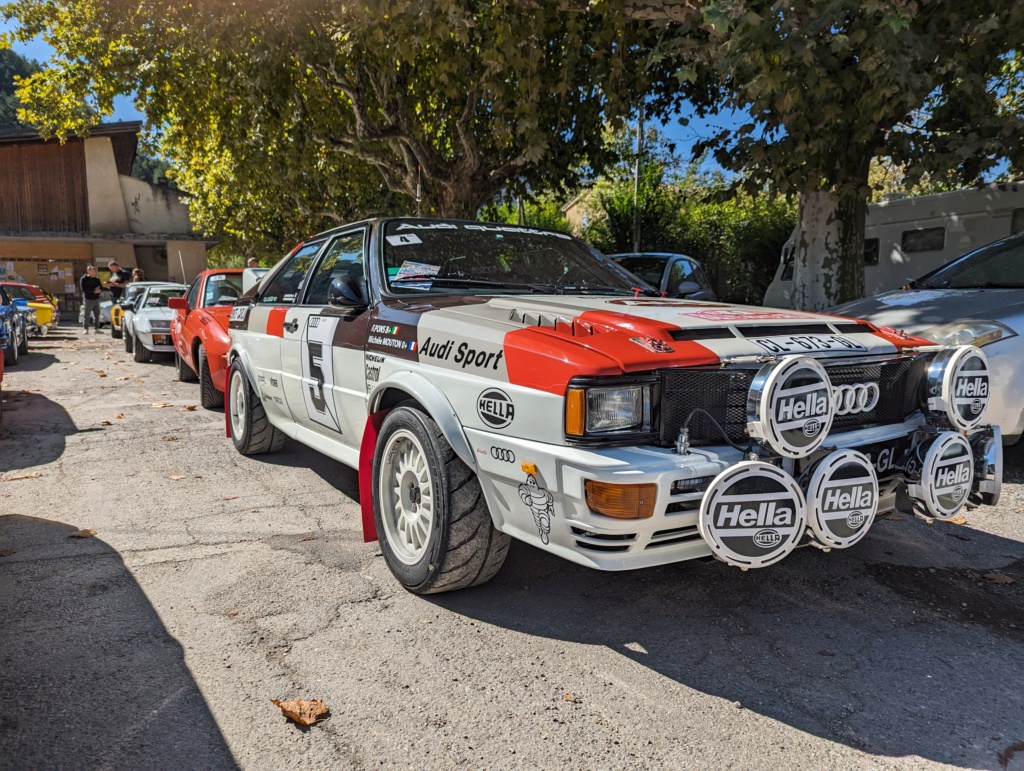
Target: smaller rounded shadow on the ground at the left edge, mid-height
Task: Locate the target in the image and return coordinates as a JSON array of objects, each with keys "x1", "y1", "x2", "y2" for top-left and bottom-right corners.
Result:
[{"x1": 0, "y1": 388, "x2": 102, "y2": 474}]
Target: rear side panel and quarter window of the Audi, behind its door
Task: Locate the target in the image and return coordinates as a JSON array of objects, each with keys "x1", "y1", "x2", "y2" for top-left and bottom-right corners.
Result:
[{"x1": 241, "y1": 241, "x2": 324, "y2": 427}]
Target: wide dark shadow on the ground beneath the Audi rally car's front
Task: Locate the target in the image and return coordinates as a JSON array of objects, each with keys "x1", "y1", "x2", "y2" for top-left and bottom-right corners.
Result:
[{"x1": 427, "y1": 483, "x2": 1024, "y2": 767}]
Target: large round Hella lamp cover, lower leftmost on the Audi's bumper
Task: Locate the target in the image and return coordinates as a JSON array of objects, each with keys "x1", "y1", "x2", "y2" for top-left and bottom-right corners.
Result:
[{"x1": 697, "y1": 461, "x2": 807, "y2": 569}]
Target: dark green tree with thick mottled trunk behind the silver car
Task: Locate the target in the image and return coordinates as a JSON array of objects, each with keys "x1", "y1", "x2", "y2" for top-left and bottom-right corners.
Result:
[{"x1": 628, "y1": 0, "x2": 1024, "y2": 308}]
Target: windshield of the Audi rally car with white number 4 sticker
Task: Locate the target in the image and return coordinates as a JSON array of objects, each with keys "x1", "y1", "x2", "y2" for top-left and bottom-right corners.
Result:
[{"x1": 383, "y1": 219, "x2": 636, "y2": 295}]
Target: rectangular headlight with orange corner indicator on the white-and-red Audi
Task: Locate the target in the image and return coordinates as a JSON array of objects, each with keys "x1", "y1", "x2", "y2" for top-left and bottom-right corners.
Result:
[{"x1": 565, "y1": 380, "x2": 653, "y2": 439}]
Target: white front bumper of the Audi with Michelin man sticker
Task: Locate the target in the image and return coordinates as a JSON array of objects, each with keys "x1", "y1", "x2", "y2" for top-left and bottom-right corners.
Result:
[{"x1": 466, "y1": 416, "x2": 994, "y2": 570}]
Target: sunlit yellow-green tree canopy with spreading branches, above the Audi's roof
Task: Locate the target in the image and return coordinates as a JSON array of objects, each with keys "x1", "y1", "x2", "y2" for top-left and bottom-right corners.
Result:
[{"x1": 2, "y1": 0, "x2": 652, "y2": 221}]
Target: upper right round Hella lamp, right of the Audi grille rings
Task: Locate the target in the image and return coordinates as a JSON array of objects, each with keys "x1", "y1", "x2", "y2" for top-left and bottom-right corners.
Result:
[{"x1": 928, "y1": 345, "x2": 991, "y2": 431}]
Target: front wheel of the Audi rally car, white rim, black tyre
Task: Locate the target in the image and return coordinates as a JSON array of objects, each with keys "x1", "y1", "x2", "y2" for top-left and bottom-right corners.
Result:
[{"x1": 373, "y1": 405, "x2": 511, "y2": 594}]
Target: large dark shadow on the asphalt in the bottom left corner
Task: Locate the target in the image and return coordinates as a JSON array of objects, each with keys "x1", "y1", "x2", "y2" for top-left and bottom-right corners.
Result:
[{"x1": 0, "y1": 514, "x2": 237, "y2": 768}]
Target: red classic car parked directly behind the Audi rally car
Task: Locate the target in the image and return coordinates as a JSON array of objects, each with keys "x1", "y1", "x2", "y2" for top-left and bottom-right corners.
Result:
[{"x1": 168, "y1": 268, "x2": 243, "y2": 410}]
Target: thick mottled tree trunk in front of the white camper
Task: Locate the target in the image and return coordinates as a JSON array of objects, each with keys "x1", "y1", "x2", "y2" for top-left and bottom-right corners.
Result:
[{"x1": 793, "y1": 189, "x2": 867, "y2": 310}]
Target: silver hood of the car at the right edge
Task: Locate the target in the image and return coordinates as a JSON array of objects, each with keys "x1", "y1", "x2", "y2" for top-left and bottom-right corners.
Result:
[{"x1": 829, "y1": 289, "x2": 1024, "y2": 333}]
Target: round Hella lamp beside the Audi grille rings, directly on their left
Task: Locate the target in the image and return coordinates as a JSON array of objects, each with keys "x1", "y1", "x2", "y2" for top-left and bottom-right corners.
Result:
[{"x1": 746, "y1": 356, "x2": 837, "y2": 458}]
